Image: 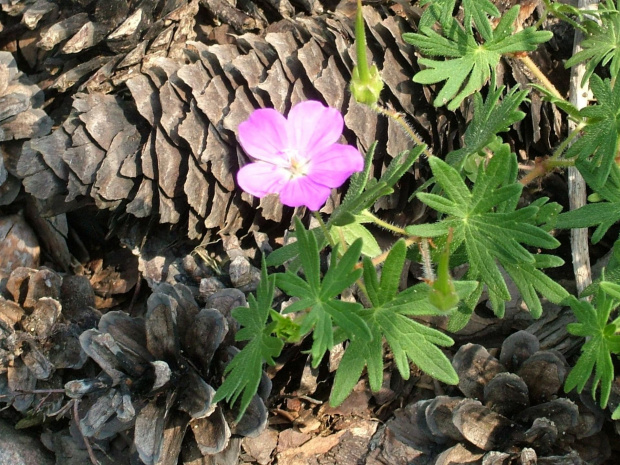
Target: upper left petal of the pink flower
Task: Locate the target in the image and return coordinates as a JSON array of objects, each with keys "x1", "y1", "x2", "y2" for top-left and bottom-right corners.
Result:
[{"x1": 239, "y1": 108, "x2": 289, "y2": 164}]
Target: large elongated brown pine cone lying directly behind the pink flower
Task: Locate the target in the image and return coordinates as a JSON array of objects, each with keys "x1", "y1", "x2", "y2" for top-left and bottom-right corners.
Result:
[{"x1": 3, "y1": 2, "x2": 456, "y2": 243}]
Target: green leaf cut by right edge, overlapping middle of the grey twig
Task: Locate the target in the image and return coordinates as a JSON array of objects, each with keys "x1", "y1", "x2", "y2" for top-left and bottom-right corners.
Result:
[{"x1": 555, "y1": 163, "x2": 620, "y2": 244}]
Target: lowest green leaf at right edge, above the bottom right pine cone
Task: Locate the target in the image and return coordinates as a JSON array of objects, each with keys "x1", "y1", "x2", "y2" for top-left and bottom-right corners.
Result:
[{"x1": 564, "y1": 290, "x2": 620, "y2": 408}]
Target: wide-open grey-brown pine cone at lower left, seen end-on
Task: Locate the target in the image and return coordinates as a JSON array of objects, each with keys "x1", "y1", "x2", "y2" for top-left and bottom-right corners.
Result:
[{"x1": 65, "y1": 284, "x2": 270, "y2": 464}]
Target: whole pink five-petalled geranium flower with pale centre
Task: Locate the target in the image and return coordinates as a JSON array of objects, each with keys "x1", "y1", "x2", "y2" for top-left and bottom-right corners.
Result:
[{"x1": 237, "y1": 100, "x2": 364, "y2": 211}]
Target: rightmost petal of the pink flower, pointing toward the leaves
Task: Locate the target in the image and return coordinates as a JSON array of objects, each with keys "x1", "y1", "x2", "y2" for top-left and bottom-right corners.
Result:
[{"x1": 307, "y1": 144, "x2": 364, "y2": 187}]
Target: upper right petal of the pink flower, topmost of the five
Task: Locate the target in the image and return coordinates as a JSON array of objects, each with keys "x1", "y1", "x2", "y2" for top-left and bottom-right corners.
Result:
[{"x1": 288, "y1": 100, "x2": 344, "y2": 158}]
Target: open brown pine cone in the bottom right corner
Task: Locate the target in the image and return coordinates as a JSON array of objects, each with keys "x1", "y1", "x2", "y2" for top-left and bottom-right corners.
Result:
[{"x1": 370, "y1": 331, "x2": 611, "y2": 465}]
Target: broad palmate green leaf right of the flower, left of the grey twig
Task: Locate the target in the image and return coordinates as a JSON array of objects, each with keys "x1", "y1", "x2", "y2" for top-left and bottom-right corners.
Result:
[{"x1": 418, "y1": 149, "x2": 565, "y2": 324}]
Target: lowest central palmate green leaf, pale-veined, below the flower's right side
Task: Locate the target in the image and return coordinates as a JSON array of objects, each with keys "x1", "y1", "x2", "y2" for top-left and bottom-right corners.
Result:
[{"x1": 330, "y1": 240, "x2": 460, "y2": 405}]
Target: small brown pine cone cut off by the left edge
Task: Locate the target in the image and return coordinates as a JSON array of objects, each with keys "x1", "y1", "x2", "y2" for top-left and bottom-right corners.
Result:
[{"x1": 0, "y1": 267, "x2": 98, "y2": 414}]
